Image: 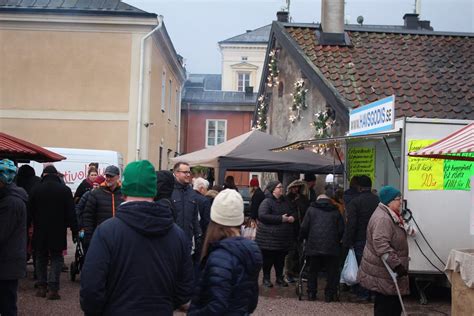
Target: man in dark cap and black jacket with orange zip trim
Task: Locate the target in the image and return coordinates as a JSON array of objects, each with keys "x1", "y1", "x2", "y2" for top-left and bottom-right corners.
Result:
[{"x1": 82, "y1": 165, "x2": 123, "y2": 249}]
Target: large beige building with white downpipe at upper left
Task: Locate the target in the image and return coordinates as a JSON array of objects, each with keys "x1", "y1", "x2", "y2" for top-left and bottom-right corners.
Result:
[{"x1": 0, "y1": 1, "x2": 185, "y2": 169}]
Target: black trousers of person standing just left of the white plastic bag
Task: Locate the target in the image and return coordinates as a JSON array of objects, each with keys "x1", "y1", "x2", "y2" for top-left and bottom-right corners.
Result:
[{"x1": 308, "y1": 255, "x2": 339, "y2": 296}]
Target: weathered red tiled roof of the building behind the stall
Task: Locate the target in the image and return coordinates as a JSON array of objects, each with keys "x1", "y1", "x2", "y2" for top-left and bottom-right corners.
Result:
[{"x1": 285, "y1": 25, "x2": 474, "y2": 119}]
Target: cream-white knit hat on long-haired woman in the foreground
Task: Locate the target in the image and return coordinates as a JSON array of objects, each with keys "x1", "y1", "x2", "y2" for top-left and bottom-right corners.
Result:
[{"x1": 211, "y1": 189, "x2": 244, "y2": 227}]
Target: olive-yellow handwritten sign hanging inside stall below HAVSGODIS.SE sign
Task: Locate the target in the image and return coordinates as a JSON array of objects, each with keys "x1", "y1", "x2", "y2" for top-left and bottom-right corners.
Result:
[{"x1": 349, "y1": 147, "x2": 375, "y2": 183}]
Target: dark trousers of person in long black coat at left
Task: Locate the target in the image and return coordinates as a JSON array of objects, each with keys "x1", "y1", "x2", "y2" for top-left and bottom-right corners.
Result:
[{"x1": 36, "y1": 249, "x2": 64, "y2": 291}]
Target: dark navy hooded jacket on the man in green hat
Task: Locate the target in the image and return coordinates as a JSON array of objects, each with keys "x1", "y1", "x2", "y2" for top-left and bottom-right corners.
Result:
[{"x1": 80, "y1": 201, "x2": 193, "y2": 315}]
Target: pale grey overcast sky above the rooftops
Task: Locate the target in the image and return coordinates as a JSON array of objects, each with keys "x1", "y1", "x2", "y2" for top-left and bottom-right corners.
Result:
[{"x1": 126, "y1": 0, "x2": 474, "y2": 73}]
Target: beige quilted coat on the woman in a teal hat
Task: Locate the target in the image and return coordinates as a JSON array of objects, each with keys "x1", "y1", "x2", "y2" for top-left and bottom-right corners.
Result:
[{"x1": 357, "y1": 203, "x2": 410, "y2": 295}]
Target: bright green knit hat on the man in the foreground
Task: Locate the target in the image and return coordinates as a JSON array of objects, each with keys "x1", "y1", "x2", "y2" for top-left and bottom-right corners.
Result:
[{"x1": 121, "y1": 160, "x2": 156, "y2": 198}]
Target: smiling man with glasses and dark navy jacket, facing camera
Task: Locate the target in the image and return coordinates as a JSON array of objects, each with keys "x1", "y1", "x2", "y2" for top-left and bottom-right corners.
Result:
[{"x1": 171, "y1": 162, "x2": 201, "y2": 262}]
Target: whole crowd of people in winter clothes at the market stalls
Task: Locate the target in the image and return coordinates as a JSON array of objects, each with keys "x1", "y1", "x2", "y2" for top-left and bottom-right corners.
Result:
[{"x1": 0, "y1": 159, "x2": 413, "y2": 315}]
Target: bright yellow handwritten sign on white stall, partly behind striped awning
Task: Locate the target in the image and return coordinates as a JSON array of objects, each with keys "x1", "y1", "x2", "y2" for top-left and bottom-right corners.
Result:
[{"x1": 408, "y1": 139, "x2": 444, "y2": 190}]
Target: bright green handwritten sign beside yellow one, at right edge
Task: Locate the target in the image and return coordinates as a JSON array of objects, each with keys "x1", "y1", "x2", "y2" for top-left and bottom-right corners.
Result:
[{"x1": 444, "y1": 153, "x2": 474, "y2": 191}]
